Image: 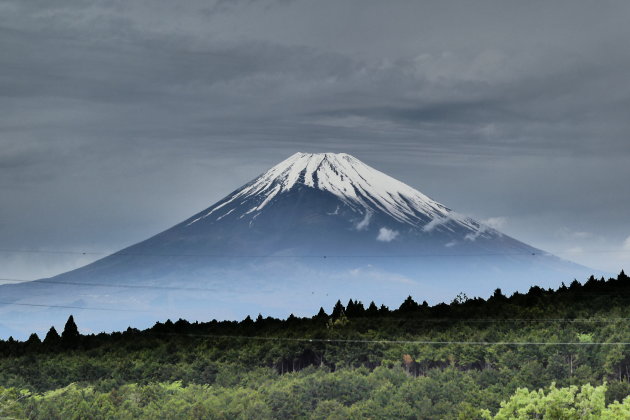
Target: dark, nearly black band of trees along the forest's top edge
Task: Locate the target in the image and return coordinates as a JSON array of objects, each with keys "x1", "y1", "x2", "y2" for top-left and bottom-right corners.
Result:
[{"x1": 0, "y1": 271, "x2": 630, "y2": 360}]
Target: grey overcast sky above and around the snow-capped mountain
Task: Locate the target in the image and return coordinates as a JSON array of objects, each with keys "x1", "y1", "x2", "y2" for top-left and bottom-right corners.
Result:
[{"x1": 0, "y1": 0, "x2": 630, "y2": 279}]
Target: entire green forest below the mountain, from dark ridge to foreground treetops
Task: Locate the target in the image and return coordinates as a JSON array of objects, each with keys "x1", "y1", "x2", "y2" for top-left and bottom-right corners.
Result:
[{"x1": 0, "y1": 271, "x2": 630, "y2": 419}]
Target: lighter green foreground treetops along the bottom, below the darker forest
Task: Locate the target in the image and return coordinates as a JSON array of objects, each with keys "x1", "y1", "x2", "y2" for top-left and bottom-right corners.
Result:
[{"x1": 6, "y1": 367, "x2": 630, "y2": 420}]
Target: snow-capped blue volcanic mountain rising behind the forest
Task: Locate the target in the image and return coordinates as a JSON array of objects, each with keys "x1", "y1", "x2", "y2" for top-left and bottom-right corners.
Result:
[{"x1": 0, "y1": 153, "x2": 590, "y2": 332}]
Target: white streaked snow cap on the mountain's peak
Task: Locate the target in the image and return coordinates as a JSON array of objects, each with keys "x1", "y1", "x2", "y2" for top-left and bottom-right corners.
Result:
[{"x1": 189, "y1": 153, "x2": 478, "y2": 230}]
